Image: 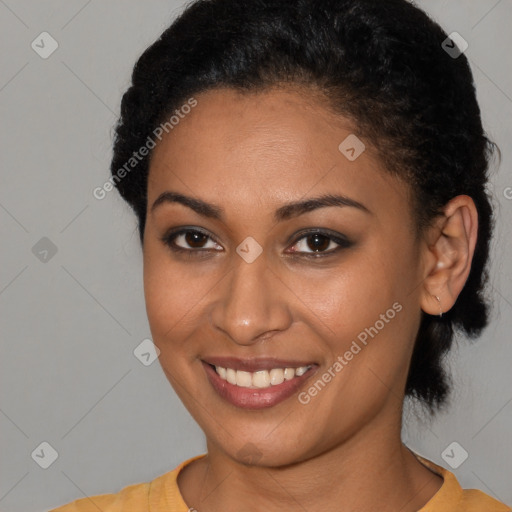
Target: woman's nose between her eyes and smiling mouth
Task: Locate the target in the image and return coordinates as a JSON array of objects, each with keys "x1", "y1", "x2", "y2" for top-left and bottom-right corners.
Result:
[{"x1": 211, "y1": 247, "x2": 292, "y2": 345}]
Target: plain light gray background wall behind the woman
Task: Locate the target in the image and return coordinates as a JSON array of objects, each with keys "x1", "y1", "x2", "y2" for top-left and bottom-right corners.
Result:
[{"x1": 0, "y1": 0, "x2": 512, "y2": 512}]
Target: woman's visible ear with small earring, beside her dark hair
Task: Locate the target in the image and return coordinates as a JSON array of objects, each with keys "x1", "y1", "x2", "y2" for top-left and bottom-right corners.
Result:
[{"x1": 420, "y1": 195, "x2": 478, "y2": 315}]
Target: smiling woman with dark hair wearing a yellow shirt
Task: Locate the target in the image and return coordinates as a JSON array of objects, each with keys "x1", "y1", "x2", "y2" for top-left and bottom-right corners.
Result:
[{"x1": 55, "y1": 0, "x2": 510, "y2": 512}]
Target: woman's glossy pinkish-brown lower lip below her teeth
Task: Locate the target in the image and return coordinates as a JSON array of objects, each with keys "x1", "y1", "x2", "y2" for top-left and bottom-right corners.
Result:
[{"x1": 202, "y1": 361, "x2": 315, "y2": 409}]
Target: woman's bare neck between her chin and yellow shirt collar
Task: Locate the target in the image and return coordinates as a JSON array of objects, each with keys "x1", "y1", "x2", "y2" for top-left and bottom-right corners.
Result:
[{"x1": 178, "y1": 406, "x2": 442, "y2": 512}]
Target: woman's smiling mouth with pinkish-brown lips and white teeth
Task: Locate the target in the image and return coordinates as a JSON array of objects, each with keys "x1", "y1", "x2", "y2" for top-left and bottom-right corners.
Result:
[{"x1": 202, "y1": 358, "x2": 318, "y2": 409}]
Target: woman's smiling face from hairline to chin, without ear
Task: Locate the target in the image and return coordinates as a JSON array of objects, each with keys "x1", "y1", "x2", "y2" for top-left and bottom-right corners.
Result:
[{"x1": 143, "y1": 89, "x2": 428, "y2": 465}]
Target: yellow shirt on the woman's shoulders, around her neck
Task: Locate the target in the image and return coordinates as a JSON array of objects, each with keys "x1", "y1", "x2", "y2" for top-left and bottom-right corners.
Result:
[{"x1": 49, "y1": 454, "x2": 512, "y2": 512}]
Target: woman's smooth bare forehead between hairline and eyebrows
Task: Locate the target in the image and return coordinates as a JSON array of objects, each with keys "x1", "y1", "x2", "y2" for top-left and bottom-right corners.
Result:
[{"x1": 148, "y1": 85, "x2": 404, "y2": 216}]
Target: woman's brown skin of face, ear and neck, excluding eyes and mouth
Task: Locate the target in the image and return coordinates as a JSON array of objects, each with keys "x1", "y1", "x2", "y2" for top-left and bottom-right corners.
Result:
[{"x1": 143, "y1": 87, "x2": 477, "y2": 512}]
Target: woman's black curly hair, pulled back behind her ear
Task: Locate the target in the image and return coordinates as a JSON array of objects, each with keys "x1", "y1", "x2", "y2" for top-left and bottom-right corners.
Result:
[{"x1": 111, "y1": 0, "x2": 496, "y2": 413}]
